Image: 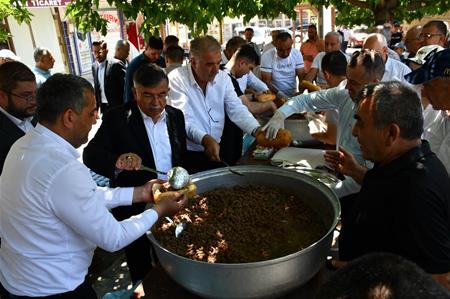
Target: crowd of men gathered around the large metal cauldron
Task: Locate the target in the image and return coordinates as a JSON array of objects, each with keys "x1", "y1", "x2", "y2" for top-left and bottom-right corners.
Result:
[{"x1": 0, "y1": 21, "x2": 450, "y2": 299}]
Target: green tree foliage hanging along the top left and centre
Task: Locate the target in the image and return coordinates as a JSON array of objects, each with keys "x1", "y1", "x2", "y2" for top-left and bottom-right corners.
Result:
[{"x1": 67, "y1": 0, "x2": 297, "y2": 35}]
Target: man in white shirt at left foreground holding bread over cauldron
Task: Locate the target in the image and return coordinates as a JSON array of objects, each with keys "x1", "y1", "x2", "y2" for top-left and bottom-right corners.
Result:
[{"x1": 0, "y1": 74, "x2": 187, "y2": 299}]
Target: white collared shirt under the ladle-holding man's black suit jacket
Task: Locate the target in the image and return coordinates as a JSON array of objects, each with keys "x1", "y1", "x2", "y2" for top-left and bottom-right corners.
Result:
[{"x1": 138, "y1": 107, "x2": 172, "y2": 180}]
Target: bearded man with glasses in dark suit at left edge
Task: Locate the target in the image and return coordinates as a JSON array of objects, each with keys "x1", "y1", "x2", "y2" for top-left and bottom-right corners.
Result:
[{"x1": 0, "y1": 61, "x2": 37, "y2": 174}]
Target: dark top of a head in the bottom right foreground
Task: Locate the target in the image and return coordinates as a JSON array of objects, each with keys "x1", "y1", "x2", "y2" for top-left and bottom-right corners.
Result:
[{"x1": 316, "y1": 253, "x2": 449, "y2": 299}]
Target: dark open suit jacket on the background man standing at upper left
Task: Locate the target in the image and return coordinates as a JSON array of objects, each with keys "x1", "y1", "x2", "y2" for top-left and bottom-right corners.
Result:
[{"x1": 92, "y1": 58, "x2": 126, "y2": 107}]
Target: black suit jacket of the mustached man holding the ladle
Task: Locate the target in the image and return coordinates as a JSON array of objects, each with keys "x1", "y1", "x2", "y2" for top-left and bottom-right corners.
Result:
[{"x1": 83, "y1": 101, "x2": 186, "y2": 218}]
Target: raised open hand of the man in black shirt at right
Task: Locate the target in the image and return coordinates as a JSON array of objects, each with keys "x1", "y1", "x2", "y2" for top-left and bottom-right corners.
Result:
[{"x1": 324, "y1": 147, "x2": 367, "y2": 184}]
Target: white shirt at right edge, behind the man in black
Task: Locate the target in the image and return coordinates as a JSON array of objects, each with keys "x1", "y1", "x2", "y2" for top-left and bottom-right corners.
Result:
[{"x1": 422, "y1": 110, "x2": 450, "y2": 175}]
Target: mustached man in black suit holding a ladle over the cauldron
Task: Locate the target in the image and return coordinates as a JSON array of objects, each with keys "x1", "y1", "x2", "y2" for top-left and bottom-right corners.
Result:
[{"x1": 83, "y1": 64, "x2": 186, "y2": 283}]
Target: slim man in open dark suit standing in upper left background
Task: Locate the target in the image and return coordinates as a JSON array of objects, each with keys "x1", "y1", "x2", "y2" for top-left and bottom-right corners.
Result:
[{"x1": 92, "y1": 41, "x2": 126, "y2": 114}]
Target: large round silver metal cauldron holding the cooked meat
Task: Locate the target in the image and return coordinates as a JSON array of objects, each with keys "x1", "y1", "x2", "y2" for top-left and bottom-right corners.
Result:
[{"x1": 148, "y1": 166, "x2": 340, "y2": 299}]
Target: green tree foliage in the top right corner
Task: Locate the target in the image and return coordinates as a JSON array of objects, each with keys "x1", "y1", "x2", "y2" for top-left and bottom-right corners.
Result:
[{"x1": 309, "y1": 0, "x2": 450, "y2": 26}]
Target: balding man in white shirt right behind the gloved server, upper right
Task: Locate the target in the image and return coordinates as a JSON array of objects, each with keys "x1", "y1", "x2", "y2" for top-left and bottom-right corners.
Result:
[{"x1": 363, "y1": 33, "x2": 411, "y2": 85}]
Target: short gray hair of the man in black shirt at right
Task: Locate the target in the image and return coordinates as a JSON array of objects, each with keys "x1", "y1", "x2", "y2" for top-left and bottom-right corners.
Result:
[{"x1": 357, "y1": 81, "x2": 423, "y2": 140}]
